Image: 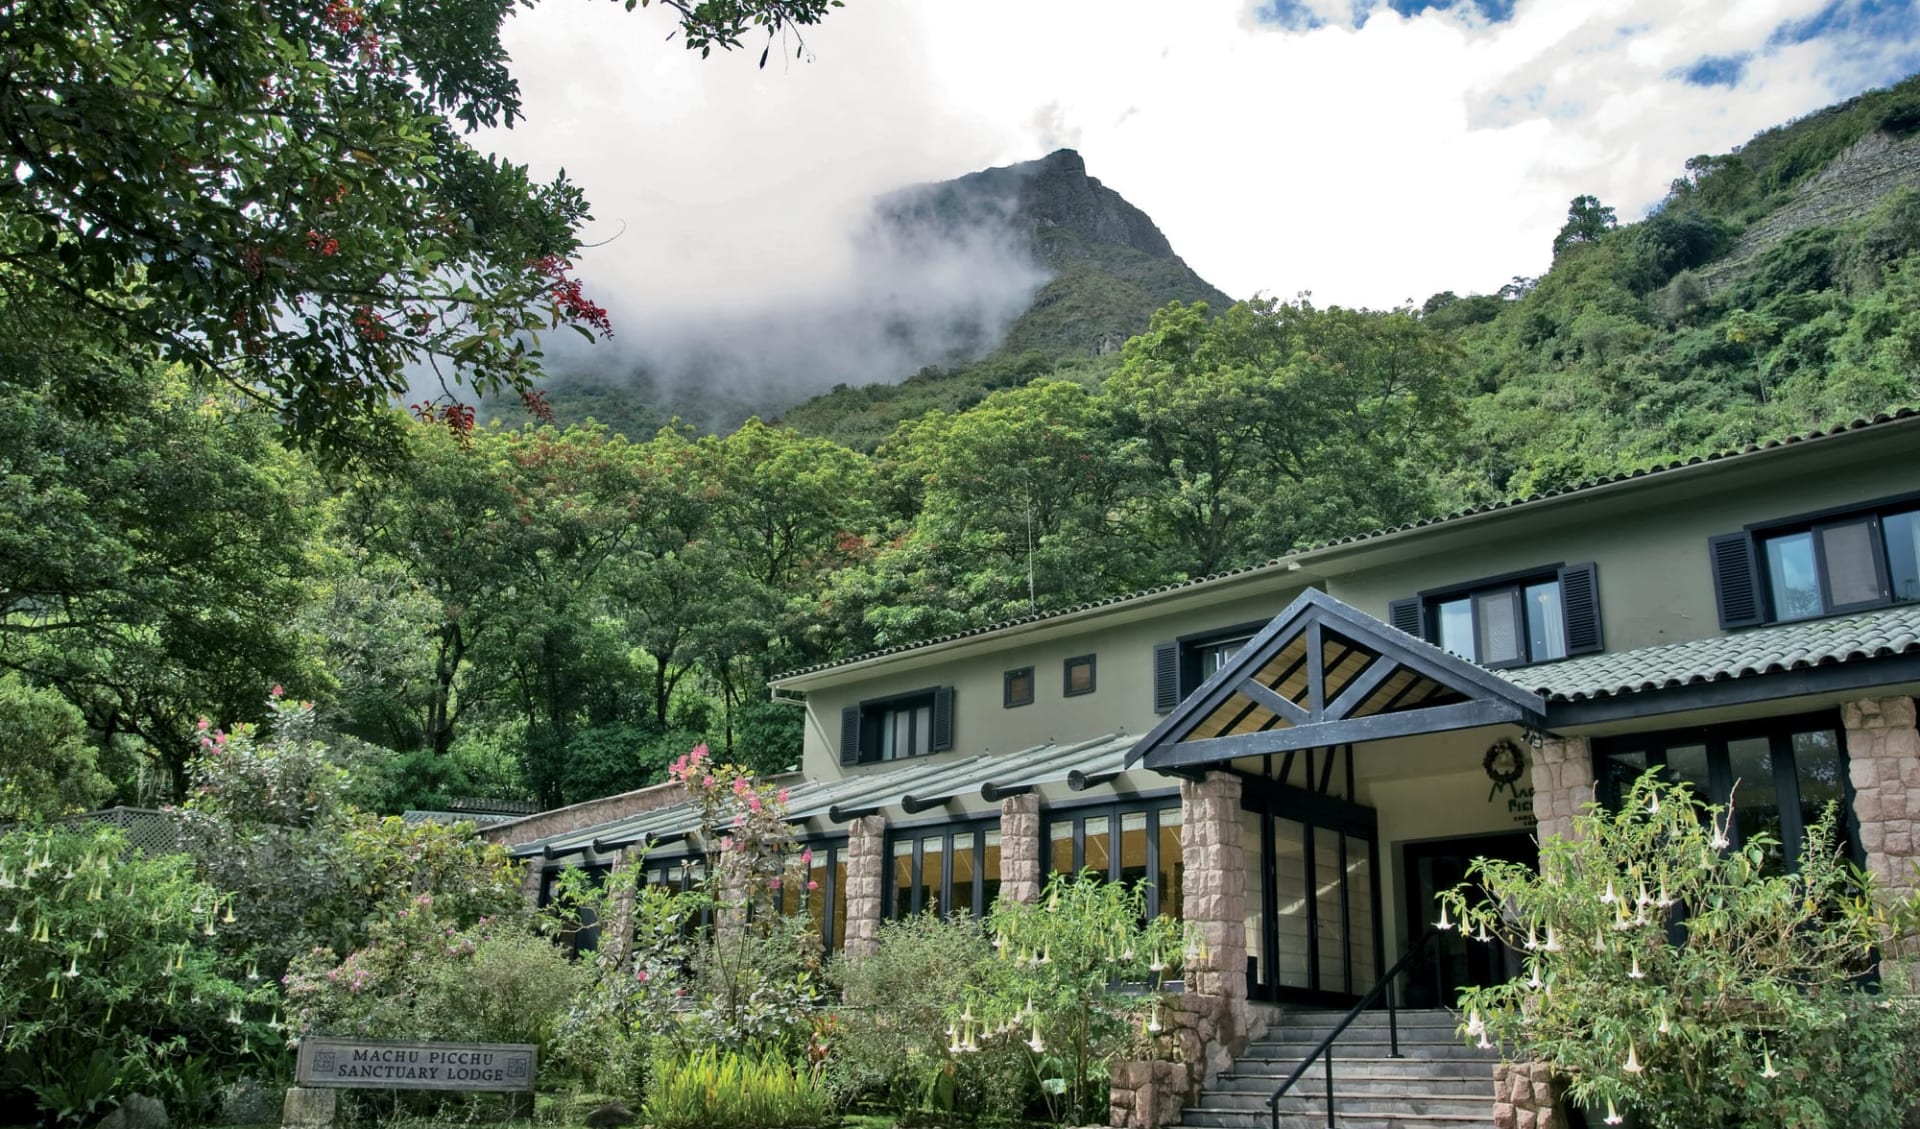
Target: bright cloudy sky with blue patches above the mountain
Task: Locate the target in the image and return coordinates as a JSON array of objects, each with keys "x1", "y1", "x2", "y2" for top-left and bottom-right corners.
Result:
[{"x1": 482, "y1": 0, "x2": 1920, "y2": 323}]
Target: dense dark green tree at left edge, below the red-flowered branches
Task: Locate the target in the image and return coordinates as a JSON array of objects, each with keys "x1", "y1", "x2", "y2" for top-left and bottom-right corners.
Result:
[{"x1": 0, "y1": 366, "x2": 317, "y2": 795}]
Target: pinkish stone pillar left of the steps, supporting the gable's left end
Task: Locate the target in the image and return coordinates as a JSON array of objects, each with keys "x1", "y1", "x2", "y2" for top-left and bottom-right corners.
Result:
[{"x1": 1181, "y1": 772, "x2": 1246, "y2": 1000}]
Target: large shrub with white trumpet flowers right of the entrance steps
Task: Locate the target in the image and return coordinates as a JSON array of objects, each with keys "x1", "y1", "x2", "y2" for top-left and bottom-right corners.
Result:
[{"x1": 1438, "y1": 772, "x2": 1916, "y2": 1129}]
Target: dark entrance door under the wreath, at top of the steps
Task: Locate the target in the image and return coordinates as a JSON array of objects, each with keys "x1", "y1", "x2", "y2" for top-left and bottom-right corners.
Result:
[{"x1": 1402, "y1": 831, "x2": 1540, "y2": 1008}]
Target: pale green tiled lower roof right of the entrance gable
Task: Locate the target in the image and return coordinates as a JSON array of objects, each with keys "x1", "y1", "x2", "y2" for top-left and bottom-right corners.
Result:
[{"x1": 1501, "y1": 605, "x2": 1920, "y2": 701}]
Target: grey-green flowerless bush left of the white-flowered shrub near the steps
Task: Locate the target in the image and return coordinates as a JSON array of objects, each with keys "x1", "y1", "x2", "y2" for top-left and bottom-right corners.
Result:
[{"x1": 824, "y1": 914, "x2": 1039, "y2": 1119}]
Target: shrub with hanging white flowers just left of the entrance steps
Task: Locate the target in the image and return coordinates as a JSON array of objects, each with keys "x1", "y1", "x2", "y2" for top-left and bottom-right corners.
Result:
[{"x1": 967, "y1": 872, "x2": 1192, "y2": 1123}]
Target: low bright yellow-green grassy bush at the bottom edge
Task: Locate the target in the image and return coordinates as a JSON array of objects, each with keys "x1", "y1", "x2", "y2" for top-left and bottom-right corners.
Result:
[{"x1": 639, "y1": 1048, "x2": 829, "y2": 1129}]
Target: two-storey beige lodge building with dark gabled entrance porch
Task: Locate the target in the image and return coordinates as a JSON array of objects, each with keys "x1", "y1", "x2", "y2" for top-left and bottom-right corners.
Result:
[{"x1": 486, "y1": 411, "x2": 1920, "y2": 1121}]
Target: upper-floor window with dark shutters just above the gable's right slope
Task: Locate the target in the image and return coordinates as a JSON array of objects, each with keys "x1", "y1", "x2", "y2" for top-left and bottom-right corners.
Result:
[{"x1": 1388, "y1": 565, "x2": 1601, "y2": 666}]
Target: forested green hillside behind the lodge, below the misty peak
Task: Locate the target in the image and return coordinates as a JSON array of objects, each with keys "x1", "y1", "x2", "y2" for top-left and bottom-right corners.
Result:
[{"x1": 0, "y1": 81, "x2": 1920, "y2": 820}]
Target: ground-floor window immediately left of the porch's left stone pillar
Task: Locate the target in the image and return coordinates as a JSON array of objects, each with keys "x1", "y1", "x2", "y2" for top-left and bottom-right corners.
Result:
[{"x1": 1046, "y1": 797, "x2": 1185, "y2": 920}]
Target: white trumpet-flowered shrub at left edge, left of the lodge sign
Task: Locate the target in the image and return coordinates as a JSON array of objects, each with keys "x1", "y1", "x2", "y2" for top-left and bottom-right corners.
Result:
[{"x1": 0, "y1": 828, "x2": 284, "y2": 1119}]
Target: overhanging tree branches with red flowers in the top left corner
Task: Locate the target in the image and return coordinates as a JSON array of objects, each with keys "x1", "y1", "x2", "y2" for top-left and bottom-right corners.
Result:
[{"x1": 0, "y1": 0, "x2": 829, "y2": 453}]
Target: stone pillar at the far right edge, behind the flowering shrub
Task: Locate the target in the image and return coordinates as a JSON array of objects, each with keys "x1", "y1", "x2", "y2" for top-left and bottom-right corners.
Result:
[{"x1": 1839, "y1": 697, "x2": 1920, "y2": 989}]
